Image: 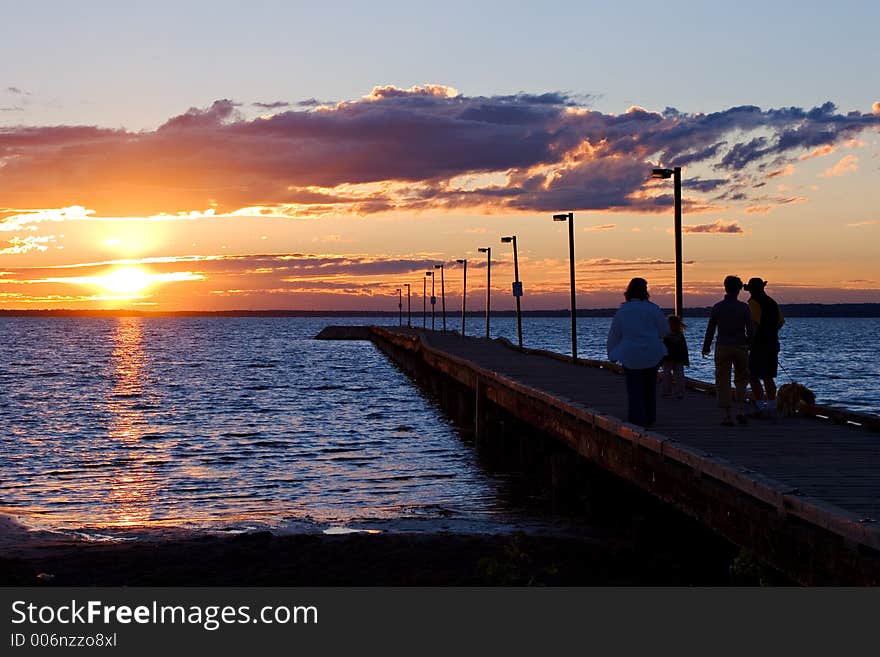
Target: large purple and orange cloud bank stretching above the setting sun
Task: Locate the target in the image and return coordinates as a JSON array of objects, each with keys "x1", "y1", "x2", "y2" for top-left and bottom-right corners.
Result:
[{"x1": 0, "y1": 84, "x2": 880, "y2": 217}]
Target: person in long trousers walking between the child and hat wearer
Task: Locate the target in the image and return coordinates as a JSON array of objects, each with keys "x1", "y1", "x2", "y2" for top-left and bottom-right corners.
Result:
[{"x1": 703, "y1": 276, "x2": 752, "y2": 427}]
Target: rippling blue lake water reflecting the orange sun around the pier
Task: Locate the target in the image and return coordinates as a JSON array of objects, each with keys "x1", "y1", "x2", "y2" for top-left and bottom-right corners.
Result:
[{"x1": 0, "y1": 318, "x2": 880, "y2": 535}]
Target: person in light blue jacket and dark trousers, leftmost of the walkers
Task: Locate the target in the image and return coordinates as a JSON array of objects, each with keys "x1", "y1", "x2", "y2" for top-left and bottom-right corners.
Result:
[{"x1": 606, "y1": 278, "x2": 669, "y2": 427}]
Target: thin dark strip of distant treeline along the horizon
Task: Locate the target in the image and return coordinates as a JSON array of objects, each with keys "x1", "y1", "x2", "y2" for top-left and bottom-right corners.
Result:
[{"x1": 0, "y1": 303, "x2": 880, "y2": 323}]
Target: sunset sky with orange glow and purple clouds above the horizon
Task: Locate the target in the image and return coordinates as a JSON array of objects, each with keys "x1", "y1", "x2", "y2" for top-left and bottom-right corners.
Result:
[{"x1": 0, "y1": 0, "x2": 880, "y2": 310}]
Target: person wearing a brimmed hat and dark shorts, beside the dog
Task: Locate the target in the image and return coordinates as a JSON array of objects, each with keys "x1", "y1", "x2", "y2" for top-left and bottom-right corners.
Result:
[{"x1": 744, "y1": 277, "x2": 785, "y2": 416}]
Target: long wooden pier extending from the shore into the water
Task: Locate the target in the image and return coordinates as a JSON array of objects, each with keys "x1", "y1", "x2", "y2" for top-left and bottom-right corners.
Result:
[{"x1": 318, "y1": 326, "x2": 880, "y2": 585}]
